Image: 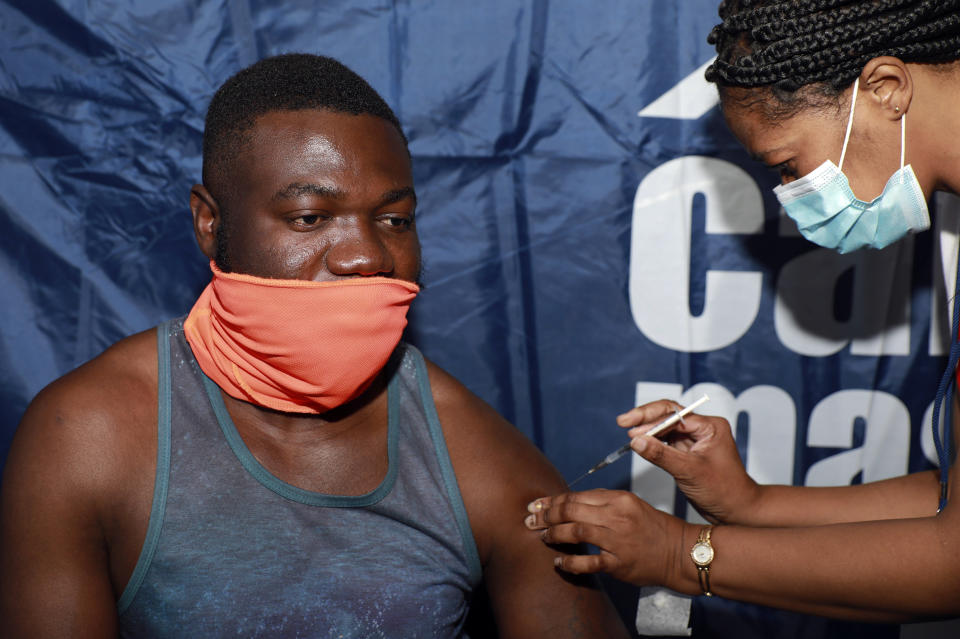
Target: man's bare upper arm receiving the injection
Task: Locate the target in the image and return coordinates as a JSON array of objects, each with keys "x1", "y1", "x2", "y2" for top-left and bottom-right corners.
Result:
[{"x1": 429, "y1": 365, "x2": 628, "y2": 639}]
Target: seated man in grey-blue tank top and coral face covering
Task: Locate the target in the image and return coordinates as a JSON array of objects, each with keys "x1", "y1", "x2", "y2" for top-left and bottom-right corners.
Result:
[{"x1": 0, "y1": 54, "x2": 626, "y2": 639}]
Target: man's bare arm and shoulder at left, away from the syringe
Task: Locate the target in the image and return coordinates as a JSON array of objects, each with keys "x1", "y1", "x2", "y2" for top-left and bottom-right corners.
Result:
[{"x1": 0, "y1": 332, "x2": 156, "y2": 639}]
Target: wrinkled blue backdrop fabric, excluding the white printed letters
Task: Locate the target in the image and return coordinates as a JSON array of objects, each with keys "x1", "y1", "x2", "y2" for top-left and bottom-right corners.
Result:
[{"x1": 0, "y1": 0, "x2": 944, "y2": 638}]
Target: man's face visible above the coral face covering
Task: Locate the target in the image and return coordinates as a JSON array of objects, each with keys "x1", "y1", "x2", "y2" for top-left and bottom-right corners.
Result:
[{"x1": 217, "y1": 109, "x2": 420, "y2": 282}]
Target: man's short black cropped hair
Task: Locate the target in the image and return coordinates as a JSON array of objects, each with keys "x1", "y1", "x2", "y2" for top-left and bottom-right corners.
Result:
[{"x1": 203, "y1": 53, "x2": 407, "y2": 204}]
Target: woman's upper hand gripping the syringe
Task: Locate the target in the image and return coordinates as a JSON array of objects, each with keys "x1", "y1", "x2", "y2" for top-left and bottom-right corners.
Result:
[{"x1": 617, "y1": 400, "x2": 761, "y2": 524}]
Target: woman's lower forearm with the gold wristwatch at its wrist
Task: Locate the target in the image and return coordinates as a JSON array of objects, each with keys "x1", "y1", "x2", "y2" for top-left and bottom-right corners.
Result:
[{"x1": 667, "y1": 513, "x2": 960, "y2": 622}]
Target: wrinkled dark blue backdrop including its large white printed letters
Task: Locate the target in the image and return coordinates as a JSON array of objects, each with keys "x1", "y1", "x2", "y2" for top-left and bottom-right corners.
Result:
[{"x1": 0, "y1": 0, "x2": 954, "y2": 637}]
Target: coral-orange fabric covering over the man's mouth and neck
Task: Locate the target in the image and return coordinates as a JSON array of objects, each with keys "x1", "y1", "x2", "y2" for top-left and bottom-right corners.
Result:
[{"x1": 183, "y1": 262, "x2": 420, "y2": 414}]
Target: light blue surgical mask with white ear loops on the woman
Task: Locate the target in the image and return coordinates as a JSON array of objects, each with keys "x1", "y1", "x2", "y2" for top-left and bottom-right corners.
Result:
[{"x1": 773, "y1": 78, "x2": 930, "y2": 253}]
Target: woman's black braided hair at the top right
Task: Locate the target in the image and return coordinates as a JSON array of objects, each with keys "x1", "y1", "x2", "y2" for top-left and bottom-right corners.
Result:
[{"x1": 706, "y1": 0, "x2": 960, "y2": 116}]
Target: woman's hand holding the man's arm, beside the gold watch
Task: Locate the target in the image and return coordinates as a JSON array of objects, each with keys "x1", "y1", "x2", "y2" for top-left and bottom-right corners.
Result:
[{"x1": 524, "y1": 489, "x2": 696, "y2": 586}]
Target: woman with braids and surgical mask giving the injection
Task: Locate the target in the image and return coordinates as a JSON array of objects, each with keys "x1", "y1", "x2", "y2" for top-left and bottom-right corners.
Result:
[{"x1": 526, "y1": 0, "x2": 960, "y2": 622}]
